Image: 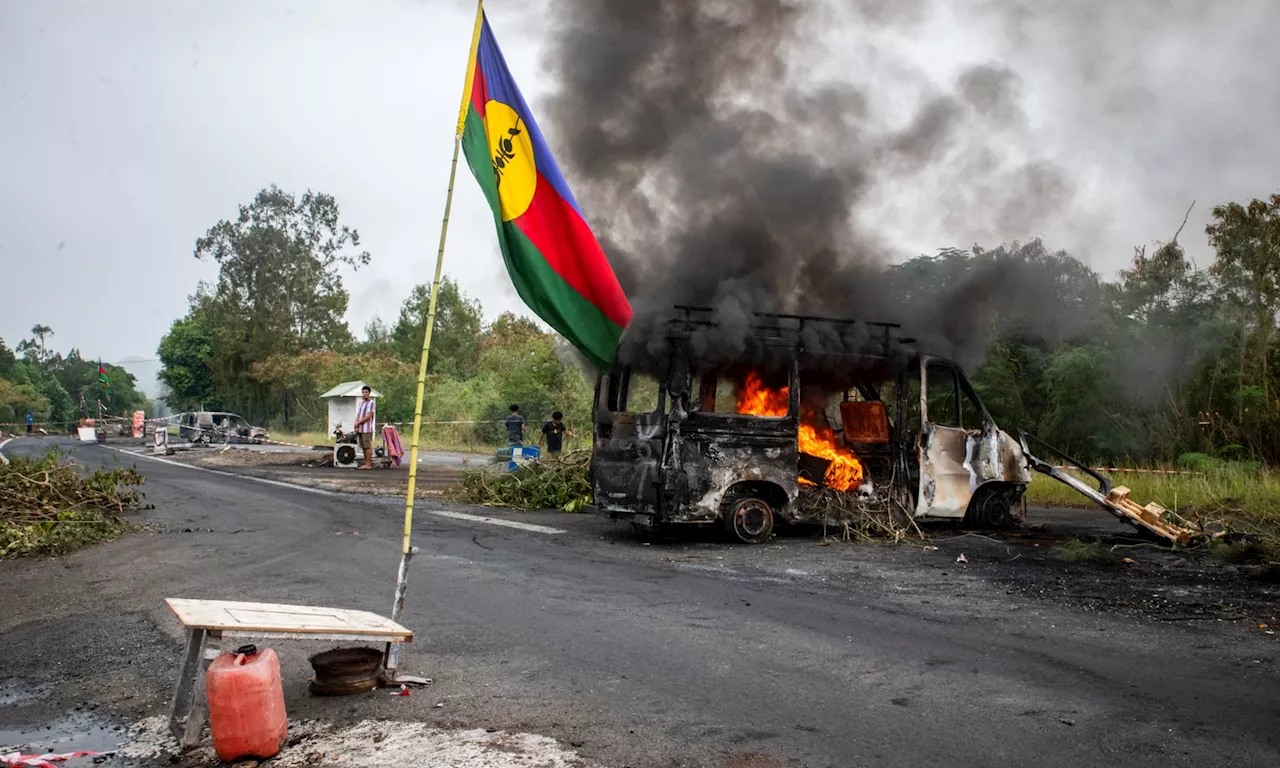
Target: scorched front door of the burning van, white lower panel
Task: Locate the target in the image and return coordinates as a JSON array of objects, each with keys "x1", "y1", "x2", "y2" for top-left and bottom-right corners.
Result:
[{"x1": 915, "y1": 358, "x2": 983, "y2": 517}]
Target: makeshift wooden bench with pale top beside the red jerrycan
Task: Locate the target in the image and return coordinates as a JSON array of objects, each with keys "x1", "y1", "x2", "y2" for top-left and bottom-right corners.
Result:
[{"x1": 165, "y1": 598, "x2": 413, "y2": 748}]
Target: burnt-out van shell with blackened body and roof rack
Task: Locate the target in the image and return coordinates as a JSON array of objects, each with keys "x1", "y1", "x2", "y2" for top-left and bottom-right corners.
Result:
[{"x1": 591, "y1": 307, "x2": 1030, "y2": 537}]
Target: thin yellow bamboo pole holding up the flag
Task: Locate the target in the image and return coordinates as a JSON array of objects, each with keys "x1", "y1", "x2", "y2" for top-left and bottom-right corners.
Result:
[{"x1": 383, "y1": 0, "x2": 484, "y2": 684}]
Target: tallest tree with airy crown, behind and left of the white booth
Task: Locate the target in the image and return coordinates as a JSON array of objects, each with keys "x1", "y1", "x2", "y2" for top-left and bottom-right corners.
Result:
[{"x1": 192, "y1": 186, "x2": 370, "y2": 419}]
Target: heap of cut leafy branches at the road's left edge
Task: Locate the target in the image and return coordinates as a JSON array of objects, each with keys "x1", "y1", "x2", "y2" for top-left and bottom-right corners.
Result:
[{"x1": 0, "y1": 452, "x2": 143, "y2": 557}]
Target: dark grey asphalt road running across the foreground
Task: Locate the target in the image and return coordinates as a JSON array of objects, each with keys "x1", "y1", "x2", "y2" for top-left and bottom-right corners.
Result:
[{"x1": 0, "y1": 440, "x2": 1280, "y2": 768}]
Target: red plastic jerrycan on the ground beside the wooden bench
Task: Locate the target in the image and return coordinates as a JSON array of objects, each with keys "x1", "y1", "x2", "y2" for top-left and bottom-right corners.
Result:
[{"x1": 205, "y1": 645, "x2": 289, "y2": 763}]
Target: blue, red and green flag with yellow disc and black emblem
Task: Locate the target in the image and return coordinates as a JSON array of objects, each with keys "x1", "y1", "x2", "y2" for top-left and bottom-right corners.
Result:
[{"x1": 458, "y1": 8, "x2": 632, "y2": 369}]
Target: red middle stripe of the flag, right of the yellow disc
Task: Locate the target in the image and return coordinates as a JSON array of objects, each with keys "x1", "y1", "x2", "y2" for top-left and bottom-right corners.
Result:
[{"x1": 513, "y1": 174, "x2": 632, "y2": 328}]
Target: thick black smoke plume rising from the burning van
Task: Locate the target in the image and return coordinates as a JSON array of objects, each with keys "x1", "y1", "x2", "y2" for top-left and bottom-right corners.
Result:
[{"x1": 537, "y1": 0, "x2": 1070, "y2": 367}]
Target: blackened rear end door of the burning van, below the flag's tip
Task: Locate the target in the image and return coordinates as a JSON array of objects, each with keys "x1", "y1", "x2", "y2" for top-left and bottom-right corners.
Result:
[{"x1": 591, "y1": 367, "x2": 666, "y2": 516}]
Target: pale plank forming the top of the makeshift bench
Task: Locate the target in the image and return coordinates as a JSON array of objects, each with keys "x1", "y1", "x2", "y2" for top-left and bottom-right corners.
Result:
[{"x1": 165, "y1": 598, "x2": 413, "y2": 639}]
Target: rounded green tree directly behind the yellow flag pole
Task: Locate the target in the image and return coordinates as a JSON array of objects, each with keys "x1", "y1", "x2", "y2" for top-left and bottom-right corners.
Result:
[{"x1": 392, "y1": 276, "x2": 483, "y2": 379}]
